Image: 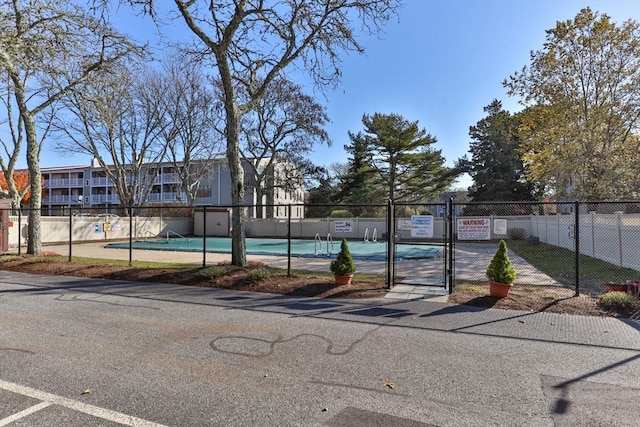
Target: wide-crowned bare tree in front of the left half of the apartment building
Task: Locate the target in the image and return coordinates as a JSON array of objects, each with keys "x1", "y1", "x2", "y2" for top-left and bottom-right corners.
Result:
[{"x1": 55, "y1": 63, "x2": 170, "y2": 212}]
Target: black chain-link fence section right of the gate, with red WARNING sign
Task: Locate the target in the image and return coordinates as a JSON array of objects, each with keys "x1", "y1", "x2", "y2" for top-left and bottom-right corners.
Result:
[{"x1": 453, "y1": 202, "x2": 640, "y2": 296}]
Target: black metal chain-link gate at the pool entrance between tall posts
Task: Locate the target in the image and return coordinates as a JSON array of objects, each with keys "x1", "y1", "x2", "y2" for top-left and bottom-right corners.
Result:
[{"x1": 387, "y1": 202, "x2": 453, "y2": 293}]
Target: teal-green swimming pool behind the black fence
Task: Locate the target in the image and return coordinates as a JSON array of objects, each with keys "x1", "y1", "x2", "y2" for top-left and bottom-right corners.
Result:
[{"x1": 105, "y1": 237, "x2": 441, "y2": 261}]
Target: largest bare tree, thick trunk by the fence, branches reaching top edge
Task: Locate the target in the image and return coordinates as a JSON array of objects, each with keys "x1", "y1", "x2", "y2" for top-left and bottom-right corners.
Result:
[{"x1": 122, "y1": 0, "x2": 400, "y2": 265}]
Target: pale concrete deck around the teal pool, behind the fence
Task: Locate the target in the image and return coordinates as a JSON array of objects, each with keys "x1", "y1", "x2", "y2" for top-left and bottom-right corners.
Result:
[{"x1": 31, "y1": 241, "x2": 560, "y2": 299}]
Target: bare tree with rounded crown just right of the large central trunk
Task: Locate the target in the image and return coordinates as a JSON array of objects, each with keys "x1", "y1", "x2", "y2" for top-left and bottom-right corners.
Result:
[{"x1": 240, "y1": 78, "x2": 331, "y2": 218}]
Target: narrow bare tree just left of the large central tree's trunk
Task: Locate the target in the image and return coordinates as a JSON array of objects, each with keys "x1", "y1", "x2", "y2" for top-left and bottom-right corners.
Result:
[{"x1": 157, "y1": 53, "x2": 223, "y2": 205}]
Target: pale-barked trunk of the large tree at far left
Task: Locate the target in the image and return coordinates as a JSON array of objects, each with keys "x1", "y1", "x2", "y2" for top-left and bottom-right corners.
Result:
[{"x1": 24, "y1": 115, "x2": 42, "y2": 255}]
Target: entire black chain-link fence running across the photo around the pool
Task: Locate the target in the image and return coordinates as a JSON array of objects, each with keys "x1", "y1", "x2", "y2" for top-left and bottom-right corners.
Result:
[{"x1": 4, "y1": 200, "x2": 640, "y2": 296}]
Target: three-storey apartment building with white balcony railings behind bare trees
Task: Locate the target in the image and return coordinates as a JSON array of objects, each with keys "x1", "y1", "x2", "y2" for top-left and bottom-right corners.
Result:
[{"x1": 42, "y1": 158, "x2": 304, "y2": 218}]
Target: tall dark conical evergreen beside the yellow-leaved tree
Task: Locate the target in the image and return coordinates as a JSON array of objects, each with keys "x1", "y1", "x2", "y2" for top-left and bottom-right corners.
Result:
[{"x1": 464, "y1": 99, "x2": 536, "y2": 202}]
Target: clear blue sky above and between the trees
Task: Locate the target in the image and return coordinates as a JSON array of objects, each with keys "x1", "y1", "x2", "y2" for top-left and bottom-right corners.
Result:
[{"x1": 41, "y1": 0, "x2": 640, "y2": 187}]
